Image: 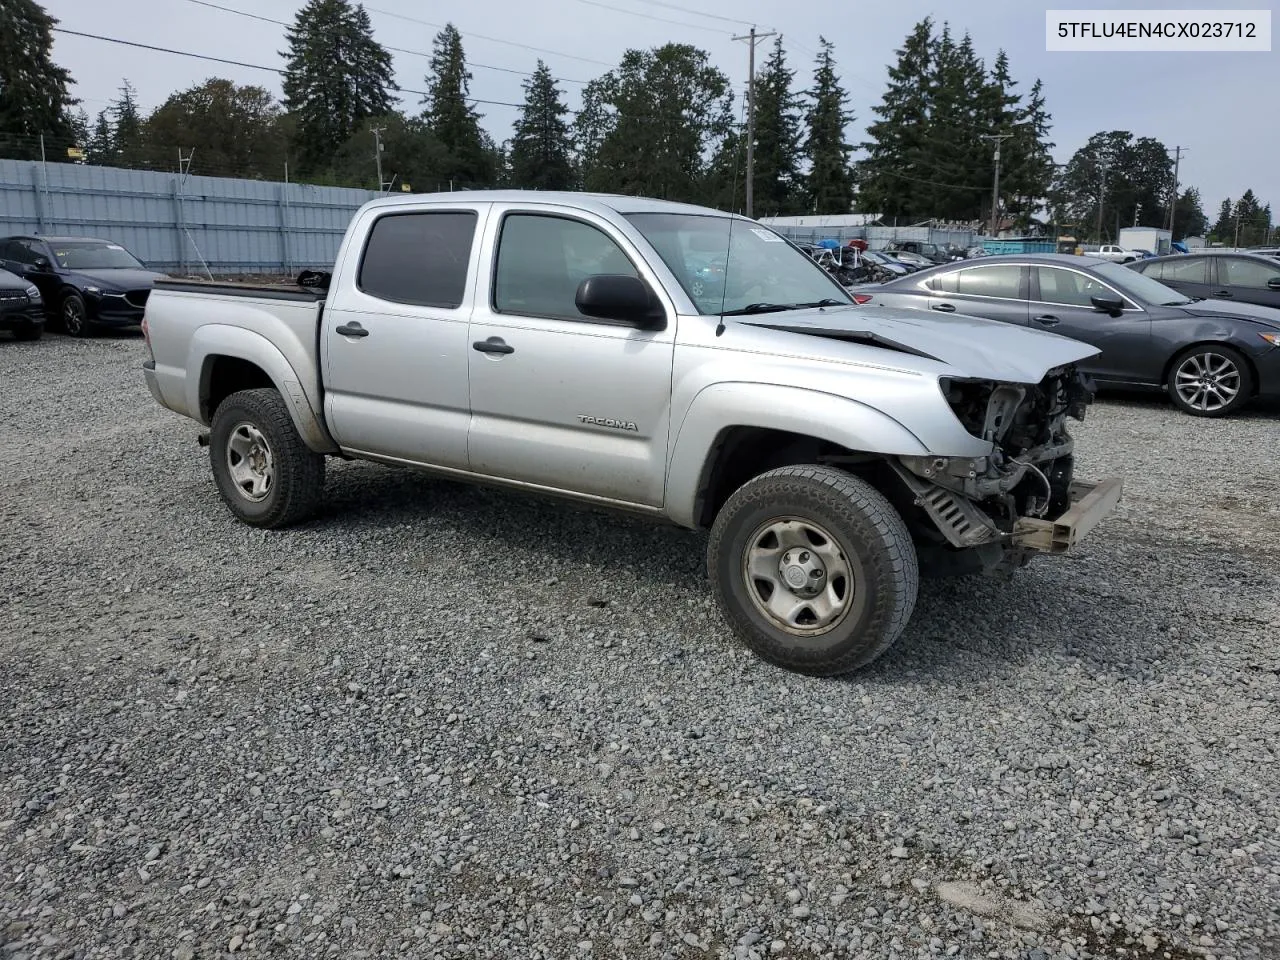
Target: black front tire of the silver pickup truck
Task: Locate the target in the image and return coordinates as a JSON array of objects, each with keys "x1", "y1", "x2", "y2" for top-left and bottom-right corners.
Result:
[{"x1": 707, "y1": 466, "x2": 919, "y2": 676}]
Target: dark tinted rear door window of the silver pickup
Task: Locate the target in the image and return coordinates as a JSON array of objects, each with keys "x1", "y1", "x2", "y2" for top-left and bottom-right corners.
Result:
[{"x1": 356, "y1": 210, "x2": 477, "y2": 310}]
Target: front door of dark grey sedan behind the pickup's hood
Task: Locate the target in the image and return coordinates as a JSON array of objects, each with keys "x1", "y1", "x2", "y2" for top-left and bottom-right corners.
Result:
[{"x1": 1030, "y1": 266, "x2": 1160, "y2": 383}]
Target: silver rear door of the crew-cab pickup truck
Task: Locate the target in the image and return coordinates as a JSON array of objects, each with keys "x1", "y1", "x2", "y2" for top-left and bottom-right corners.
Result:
[{"x1": 320, "y1": 200, "x2": 488, "y2": 470}]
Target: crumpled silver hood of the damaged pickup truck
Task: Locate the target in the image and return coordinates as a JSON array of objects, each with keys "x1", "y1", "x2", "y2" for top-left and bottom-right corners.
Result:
[{"x1": 733, "y1": 306, "x2": 1102, "y2": 384}]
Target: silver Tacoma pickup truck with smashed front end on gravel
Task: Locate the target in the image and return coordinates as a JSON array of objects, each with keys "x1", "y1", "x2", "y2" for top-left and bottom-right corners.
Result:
[{"x1": 145, "y1": 192, "x2": 1120, "y2": 675}]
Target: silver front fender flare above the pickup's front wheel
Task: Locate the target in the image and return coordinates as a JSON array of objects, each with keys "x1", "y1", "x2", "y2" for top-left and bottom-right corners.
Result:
[{"x1": 666, "y1": 381, "x2": 929, "y2": 527}]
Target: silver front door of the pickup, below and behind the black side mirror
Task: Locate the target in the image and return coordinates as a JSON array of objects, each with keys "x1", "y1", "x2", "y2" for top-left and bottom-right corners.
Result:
[{"x1": 467, "y1": 205, "x2": 676, "y2": 506}]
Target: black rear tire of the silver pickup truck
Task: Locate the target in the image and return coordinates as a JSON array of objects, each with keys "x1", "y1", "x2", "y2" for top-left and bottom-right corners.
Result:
[{"x1": 209, "y1": 389, "x2": 325, "y2": 530}]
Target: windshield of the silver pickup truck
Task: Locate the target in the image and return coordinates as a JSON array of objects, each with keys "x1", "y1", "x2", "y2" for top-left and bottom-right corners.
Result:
[{"x1": 626, "y1": 214, "x2": 854, "y2": 315}]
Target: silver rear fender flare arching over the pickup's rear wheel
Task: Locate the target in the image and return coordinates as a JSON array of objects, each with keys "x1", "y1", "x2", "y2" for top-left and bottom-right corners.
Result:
[{"x1": 187, "y1": 324, "x2": 338, "y2": 453}]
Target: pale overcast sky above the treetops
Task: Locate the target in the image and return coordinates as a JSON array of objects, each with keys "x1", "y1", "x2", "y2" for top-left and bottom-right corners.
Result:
[{"x1": 45, "y1": 0, "x2": 1280, "y2": 212}]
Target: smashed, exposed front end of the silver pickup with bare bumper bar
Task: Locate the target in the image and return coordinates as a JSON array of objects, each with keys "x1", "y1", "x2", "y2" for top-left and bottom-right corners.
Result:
[{"x1": 890, "y1": 365, "x2": 1121, "y2": 576}]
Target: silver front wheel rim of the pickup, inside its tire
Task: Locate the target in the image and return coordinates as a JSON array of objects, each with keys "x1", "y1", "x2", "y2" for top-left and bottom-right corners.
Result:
[{"x1": 742, "y1": 517, "x2": 854, "y2": 636}]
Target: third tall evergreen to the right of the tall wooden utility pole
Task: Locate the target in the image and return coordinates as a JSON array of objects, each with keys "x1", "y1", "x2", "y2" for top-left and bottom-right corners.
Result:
[{"x1": 858, "y1": 17, "x2": 938, "y2": 220}]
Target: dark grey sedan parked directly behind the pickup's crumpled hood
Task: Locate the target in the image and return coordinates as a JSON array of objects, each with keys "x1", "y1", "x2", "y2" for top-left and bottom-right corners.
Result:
[{"x1": 855, "y1": 253, "x2": 1280, "y2": 416}]
